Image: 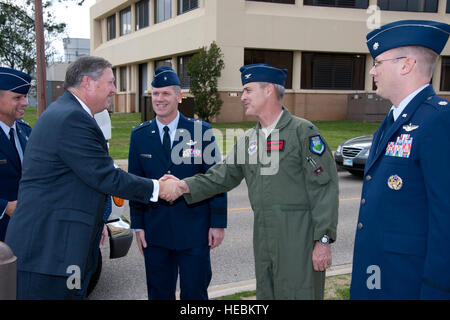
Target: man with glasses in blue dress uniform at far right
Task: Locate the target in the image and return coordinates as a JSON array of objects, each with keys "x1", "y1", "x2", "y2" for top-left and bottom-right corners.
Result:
[{"x1": 350, "y1": 20, "x2": 450, "y2": 299}]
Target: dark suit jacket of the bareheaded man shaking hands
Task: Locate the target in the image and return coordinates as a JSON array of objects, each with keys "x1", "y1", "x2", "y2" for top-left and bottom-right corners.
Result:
[{"x1": 5, "y1": 92, "x2": 153, "y2": 278}]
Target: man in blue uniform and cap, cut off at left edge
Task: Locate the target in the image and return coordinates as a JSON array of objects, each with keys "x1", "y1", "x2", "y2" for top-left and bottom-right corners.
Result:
[{"x1": 0, "y1": 67, "x2": 31, "y2": 241}]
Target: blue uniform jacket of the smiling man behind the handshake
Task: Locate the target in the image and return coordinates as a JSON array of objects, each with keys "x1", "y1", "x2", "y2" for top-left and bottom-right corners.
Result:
[{"x1": 128, "y1": 113, "x2": 227, "y2": 250}]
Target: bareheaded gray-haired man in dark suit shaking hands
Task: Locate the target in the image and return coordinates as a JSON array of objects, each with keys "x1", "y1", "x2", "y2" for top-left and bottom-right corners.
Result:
[{"x1": 5, "y1": 56, "x2": 178, "y2": 299}]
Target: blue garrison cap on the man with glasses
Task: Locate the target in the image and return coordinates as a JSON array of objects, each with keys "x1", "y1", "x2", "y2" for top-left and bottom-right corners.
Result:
[{"x1": 366, "y1": 20, "x2": 450, "y2": 58}]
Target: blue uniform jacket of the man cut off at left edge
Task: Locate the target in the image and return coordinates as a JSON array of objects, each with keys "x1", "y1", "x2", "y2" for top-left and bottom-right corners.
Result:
[{"x1": 0, "y1": 120, "x2": 31, "y2": 241}]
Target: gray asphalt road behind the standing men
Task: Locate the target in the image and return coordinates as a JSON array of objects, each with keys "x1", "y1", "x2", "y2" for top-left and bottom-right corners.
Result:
[{"x1": 89, "y1": 172, "x2": 362, "y2": 300}]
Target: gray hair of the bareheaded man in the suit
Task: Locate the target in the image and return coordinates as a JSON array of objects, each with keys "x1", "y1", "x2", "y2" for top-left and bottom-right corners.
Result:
[{"x1": 64, "y1": 56, "x2": 112, "y2": 90}]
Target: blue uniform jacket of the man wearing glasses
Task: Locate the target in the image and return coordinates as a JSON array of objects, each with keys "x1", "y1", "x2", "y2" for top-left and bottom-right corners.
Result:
[{"x1": 350, "y1": 86, "x2": 450, "y2": 299}]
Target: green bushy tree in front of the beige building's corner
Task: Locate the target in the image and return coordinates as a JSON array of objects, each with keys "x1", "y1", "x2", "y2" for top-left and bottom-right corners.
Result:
[{"x1": 187, "y1": 42, "x2": 225, "y2": 121}]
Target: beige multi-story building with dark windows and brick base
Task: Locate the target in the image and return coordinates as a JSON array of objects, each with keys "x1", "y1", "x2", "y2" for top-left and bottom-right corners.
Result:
[{"x1": 90, "y1": 0, "x2": 450, "y2": 121}]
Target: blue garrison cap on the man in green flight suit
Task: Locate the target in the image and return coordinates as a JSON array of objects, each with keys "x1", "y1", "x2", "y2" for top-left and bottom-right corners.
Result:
[{"x1": 239, "y1": 63, "x2": 288, "y2": 87}]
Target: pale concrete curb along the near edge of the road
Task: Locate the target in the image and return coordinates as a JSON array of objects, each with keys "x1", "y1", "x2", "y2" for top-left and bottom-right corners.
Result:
[{"x1": 206, "y1": 263, "x2": 352, "y2": 299}]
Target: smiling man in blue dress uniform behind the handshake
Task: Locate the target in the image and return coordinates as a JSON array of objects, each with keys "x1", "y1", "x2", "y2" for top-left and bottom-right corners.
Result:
[{"x1": 128, "y1": 67, "x2": 227, "y2": 300}]
